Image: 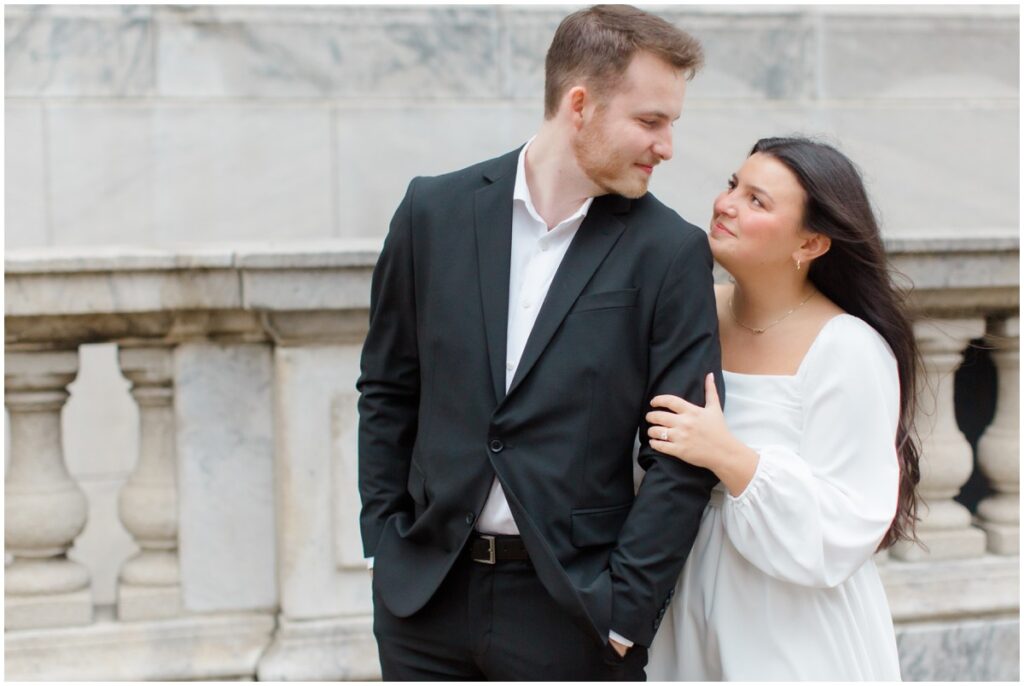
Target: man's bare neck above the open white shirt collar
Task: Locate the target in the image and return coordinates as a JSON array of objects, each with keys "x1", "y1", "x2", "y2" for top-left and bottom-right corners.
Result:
[{"x1": 524, "y1": 121, "x2": 603, "y2": 229}]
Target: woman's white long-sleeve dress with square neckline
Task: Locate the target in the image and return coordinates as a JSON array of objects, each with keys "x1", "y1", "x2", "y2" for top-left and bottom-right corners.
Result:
[{"x1": 647, "y1": 314, "x2": 900, "y2": 681}]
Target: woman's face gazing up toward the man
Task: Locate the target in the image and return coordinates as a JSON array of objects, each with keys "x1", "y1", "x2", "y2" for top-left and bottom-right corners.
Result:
[{"x1": 710, "y1": 153, "x2": 810, "y2": 273}]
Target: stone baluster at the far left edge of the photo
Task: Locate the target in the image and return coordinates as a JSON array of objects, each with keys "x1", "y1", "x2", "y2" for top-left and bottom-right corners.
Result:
[{"x1": 4, "y1": 350, "x2": 92, "y2": 629}]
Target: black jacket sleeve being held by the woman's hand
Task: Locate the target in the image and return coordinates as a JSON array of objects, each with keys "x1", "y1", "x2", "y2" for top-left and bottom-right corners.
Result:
[{"x1": 610, "y1": 229, "x2": 725, "y2": 646}]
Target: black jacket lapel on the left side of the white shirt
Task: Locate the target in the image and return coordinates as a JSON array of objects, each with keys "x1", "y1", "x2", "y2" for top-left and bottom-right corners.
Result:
[{"x1": 474, "y1": 148, "x2": 521, "y2": 402}]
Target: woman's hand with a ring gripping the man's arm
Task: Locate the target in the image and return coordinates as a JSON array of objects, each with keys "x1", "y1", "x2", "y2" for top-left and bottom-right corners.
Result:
[{"x1": 647, "y1": 374, "x2": 759, "y2": 497}]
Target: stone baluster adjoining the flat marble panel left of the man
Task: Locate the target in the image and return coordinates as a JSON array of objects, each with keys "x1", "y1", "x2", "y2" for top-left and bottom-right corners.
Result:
[{"x1": 118, "y1": 347, "x2": 181, "y2": 619}]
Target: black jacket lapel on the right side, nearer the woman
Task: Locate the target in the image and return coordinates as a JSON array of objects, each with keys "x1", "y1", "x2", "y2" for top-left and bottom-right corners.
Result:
[{"x1": 503, "y1": 196, "x2": 631, "y2": 397}]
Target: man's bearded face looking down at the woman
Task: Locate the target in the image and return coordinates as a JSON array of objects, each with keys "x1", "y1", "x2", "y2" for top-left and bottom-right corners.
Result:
[{"x1": 572, "y1": 52, "x2": 686, "y2": 198}]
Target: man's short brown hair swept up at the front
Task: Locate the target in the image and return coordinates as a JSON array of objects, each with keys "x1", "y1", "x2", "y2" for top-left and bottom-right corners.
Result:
[{"x1": 544, "y1": 5, "x2": 703, "y2": 119}]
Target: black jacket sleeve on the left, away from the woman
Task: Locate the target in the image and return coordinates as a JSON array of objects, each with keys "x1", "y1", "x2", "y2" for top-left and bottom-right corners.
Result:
[{"x1": 356, "y1": 179, "x2": 420, "y2": 557}]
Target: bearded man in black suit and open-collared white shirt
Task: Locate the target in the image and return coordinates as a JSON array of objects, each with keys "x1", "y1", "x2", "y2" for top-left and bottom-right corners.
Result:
[{"x1": 358, "y1": 5, "x2": 722, "y2": 680}]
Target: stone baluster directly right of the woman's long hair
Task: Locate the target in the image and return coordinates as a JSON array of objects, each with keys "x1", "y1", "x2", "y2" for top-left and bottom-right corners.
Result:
[{"x1": 892, "y1": 319, "x2": 985, "y2": 560}]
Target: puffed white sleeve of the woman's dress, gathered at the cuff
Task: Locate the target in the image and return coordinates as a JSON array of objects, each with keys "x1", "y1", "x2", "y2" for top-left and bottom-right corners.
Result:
[{"x1": 722, "y1": 316, "x2": 900, "y2": 588}]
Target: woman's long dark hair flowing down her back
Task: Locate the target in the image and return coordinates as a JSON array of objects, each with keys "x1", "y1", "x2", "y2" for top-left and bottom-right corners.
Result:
[{"x1": 751, "y1": 138, "x2": 921, "y2": 549}]
